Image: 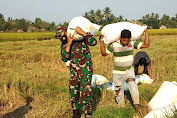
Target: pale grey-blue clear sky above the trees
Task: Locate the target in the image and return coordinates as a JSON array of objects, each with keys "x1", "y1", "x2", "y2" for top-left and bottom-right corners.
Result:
[{"x1": 0, "y1": 0, "x2": 177, "y2": 24}]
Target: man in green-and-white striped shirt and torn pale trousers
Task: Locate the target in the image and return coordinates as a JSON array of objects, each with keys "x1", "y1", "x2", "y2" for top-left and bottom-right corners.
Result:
[{"x1": 99, "y1": 29, "x2": 149, "y2": 111}]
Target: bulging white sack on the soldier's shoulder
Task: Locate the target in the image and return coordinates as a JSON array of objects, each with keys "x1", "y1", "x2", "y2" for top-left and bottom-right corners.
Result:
[{"x1": 67, "y1": 16, "x2": 101, "y2": 40}]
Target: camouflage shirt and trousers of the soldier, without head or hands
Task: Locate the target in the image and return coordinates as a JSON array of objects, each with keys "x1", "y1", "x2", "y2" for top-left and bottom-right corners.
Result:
[{"x1": 61, "y1": 36, "x2": 97, "y2": 114}]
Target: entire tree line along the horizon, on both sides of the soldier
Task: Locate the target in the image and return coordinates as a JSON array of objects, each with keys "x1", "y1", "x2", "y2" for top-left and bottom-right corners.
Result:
[{"x1": 0, "y1": 7, "x2": 177, "y2": 32}]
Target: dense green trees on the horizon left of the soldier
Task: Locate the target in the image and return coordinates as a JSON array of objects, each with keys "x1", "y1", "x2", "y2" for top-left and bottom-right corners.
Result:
[{"x1": 0, "y1": 13, "x2": 56, "y2": 32}]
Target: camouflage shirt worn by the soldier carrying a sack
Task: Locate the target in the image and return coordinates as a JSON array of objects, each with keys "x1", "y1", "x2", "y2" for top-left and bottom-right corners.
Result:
[{"x1": 61, "y1": 37, "x2": 97, "y2": 68}]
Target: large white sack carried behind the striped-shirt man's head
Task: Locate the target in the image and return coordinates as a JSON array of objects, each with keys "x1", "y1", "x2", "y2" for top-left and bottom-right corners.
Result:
[{"x1": 101, "y1": 22, "x2": 147, "y2": 44}]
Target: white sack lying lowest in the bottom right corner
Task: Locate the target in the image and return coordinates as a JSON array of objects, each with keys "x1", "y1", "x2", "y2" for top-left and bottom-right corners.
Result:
[{"x1": 144, "y1": 103, "x2": 177, "y2": 118}]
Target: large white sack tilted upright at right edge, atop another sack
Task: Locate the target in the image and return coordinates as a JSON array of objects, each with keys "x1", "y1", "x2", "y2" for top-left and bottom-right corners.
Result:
[{"x1": 148, "y1": 81, "x2": 177, "y2": 109}]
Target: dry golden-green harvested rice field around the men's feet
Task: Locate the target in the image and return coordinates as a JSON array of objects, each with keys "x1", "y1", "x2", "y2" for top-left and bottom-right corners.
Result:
[{"x1": 0, "y1": 35, "x2": 177, "y2": 118}]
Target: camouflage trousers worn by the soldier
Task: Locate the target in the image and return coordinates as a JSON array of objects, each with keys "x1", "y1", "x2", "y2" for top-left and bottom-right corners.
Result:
[{"x1": 69, "y1": 67, "x2": 93, "y2": 114}]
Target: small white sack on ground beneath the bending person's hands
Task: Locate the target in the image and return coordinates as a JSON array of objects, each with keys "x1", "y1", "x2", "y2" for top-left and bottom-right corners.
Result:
[{"x1": 135, "y1": 74, "x2": 154, "y2": 84}]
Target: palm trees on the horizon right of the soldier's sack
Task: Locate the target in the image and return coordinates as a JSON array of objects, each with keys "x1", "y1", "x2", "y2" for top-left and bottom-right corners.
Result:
[{"x1": 83, "y1": 7, "x2": 177, "y2": 29}]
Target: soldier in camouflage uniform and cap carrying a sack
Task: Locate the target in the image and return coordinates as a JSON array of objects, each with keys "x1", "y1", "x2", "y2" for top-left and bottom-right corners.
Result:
[{"x1": 58, "y1": 26, "x2": 97, "y2": 118}]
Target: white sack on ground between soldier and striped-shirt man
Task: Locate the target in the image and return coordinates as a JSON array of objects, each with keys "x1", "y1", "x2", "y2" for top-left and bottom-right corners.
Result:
[{"x1": 91, "y1": 74, "x2": 108, "y2": 87}]
